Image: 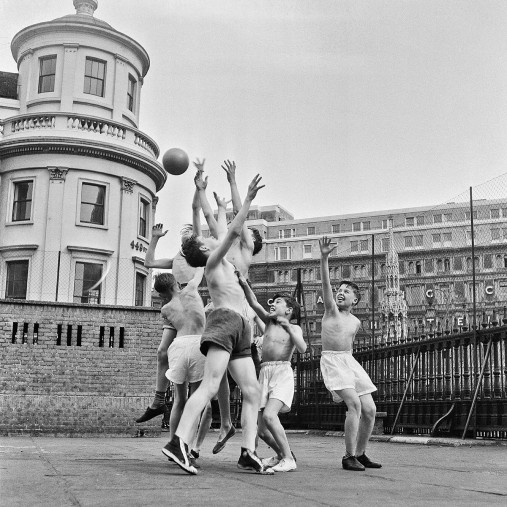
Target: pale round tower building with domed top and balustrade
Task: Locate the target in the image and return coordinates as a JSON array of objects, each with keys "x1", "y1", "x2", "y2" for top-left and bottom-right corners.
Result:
[{"x1": 0, "y1": 0, "x2": 166, "y2": 306}]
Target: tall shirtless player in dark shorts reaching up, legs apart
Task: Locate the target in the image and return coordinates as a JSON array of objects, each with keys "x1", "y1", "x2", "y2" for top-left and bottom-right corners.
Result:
[{"x1": 162, "y1": 175, "x2": 273, "y2": 474}]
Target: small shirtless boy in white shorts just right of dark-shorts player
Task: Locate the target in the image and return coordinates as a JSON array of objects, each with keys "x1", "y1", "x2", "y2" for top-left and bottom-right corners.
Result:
[{"x1": 238, "y1": 273, "x2": 306, "y2": 472}]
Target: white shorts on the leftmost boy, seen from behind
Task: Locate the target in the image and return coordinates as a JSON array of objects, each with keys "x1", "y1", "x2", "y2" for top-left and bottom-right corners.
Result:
[{"x1": 165, "y1": 334, "x2": 206, "y2": 384}]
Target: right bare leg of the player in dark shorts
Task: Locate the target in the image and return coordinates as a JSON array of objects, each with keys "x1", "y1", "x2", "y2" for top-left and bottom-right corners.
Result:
[{"x1": 229, "y1": 357, "x2": 260, "y2": 452}]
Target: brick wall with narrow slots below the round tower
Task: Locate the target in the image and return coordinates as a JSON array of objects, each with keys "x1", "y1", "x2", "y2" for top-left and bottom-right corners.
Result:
[{"x1": 0, "y1": 300, "x2": 166, "y2": 436}]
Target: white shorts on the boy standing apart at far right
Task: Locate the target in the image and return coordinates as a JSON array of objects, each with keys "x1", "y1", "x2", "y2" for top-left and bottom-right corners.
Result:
[{"x1": 320, "y1": 350, "x2": 377, "y2": 403}]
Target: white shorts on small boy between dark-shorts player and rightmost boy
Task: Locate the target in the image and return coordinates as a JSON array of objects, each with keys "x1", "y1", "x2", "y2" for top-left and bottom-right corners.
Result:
[{"x1": 259, "y1": 361, "x2": 294, "y2": 413}]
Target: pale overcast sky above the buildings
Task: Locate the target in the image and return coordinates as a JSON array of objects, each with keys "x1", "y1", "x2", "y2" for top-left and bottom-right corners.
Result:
[{"x1": 0, "y1": 0, "x2": 507, "y2": 254}]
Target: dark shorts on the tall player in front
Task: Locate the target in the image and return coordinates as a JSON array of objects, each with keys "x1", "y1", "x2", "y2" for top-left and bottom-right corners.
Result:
[{"x1": 201, "y1": 308, "x2": 252, "y2": 359}]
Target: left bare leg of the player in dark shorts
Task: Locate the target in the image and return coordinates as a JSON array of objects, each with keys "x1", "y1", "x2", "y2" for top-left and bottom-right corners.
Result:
[{"x1": 175, "y1": 345, "x2": 230, "y2": 445}]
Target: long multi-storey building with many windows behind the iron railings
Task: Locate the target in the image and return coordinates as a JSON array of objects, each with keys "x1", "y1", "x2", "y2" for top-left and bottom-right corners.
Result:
[{"x1": 202, "y1": 199, "x2": 507, "y2": 341}]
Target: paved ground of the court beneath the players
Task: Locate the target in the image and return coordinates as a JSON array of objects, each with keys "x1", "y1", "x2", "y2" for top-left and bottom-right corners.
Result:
[{"x1": 0, "y1": 432, "x2": 507, "y2": 507}]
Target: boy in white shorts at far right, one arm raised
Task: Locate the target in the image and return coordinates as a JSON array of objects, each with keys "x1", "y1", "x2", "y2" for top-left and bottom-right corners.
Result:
[{"x1": 319, "y1": 236, "x2": 382, "y2": 471}]
